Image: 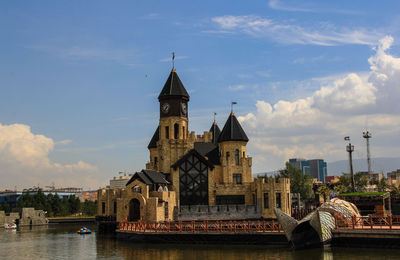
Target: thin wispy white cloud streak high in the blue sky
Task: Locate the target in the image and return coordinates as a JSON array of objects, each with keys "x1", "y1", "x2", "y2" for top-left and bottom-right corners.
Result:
[{"x1": 209, "y1": 15, "x2": 382, "y2": 46}]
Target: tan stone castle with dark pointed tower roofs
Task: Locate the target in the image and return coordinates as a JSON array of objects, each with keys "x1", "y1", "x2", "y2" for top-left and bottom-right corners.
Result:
[{"x1": 98, "y1": 69, "x2": 291, "y2": 221}]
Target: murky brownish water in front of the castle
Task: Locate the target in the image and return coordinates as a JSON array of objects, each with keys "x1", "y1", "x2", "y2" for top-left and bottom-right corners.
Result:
[{"x1": 0, "y1": 225, "x2": 400, "y2": 260}]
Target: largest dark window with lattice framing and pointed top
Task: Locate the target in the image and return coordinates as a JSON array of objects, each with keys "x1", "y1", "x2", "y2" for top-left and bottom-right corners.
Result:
[{"x1": 179, "y1": 155, "x2": 208, "y2": 205}]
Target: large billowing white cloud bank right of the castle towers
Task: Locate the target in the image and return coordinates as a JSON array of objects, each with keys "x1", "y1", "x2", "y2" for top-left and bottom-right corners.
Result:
[{"x1": 238, "y1": 36, "x2": 400, "y2": 171}]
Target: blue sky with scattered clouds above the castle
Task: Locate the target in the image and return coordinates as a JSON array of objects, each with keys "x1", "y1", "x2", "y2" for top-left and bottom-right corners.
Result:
[{"x1": 0, "y1": 0, "x2": 400, "y2": 190}]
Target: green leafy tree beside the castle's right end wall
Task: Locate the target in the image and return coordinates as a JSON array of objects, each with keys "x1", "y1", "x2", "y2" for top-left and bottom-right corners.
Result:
[{"x1": 277, "y1": 162, "x2": 313, "y2": 201}]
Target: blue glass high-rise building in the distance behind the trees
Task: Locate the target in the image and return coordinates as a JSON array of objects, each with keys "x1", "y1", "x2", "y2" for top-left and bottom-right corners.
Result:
[{"x1": 289, "y1": 158, "x2": 328, "y2": 183}]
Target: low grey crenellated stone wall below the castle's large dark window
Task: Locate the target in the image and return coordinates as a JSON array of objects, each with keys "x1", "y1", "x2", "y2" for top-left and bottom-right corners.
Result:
[{"x1": 175, "y1": 205, "x2": 262, "y2": 220}]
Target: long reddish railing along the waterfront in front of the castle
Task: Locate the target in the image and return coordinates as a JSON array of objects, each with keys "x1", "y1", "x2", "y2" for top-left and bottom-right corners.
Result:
[{"x1": 118, "y1": 220, "x2": 283, "y2": 233}]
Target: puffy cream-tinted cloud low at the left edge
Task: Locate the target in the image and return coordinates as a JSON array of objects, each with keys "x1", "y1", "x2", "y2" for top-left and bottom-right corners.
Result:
[{"x1": 0, "y1": 124, "x2": 100, "y2": 188}]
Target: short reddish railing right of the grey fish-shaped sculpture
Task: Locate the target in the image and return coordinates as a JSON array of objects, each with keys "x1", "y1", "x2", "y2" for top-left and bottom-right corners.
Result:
[{"x1": 335, "y1": 215, "x2": 400, "y2": 229}]
